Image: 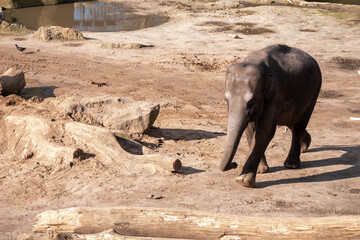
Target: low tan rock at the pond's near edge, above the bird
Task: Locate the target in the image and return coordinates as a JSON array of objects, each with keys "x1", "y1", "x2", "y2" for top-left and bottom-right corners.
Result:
[{"x1": 33, "y1": 26, "x2": 85, "y2": 41}]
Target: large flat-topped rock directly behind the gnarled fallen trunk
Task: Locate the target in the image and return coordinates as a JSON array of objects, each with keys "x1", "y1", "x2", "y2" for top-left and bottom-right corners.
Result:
[{"x1": 46, "y1": 93, "x2": 160, "y2": 134}]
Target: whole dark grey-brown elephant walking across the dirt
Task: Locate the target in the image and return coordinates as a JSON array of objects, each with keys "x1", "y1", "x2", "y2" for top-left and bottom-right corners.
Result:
[{"x1": 220, "y1": 45, "x2": 321, "y2": 187}]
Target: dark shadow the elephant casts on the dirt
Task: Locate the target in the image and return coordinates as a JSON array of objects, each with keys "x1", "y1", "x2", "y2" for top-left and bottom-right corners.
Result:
[{"x1": 256, "y1": 145, "x2": 360, "y2": 188}]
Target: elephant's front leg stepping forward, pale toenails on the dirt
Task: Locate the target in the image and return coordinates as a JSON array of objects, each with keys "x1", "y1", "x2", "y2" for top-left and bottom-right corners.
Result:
[{"x1": 236, "y1": 118, "x2": 276, "y2": 187}]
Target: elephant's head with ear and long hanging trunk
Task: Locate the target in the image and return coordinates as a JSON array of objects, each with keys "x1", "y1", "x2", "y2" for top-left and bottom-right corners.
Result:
[{"x1": 220, "y1": 62, "x2": 273, "y2": 171}]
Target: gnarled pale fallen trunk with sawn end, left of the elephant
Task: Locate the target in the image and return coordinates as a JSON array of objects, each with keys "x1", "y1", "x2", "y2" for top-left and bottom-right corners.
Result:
[{"x1": 4, "y1": 114, "x2": 182, "y2": 176}]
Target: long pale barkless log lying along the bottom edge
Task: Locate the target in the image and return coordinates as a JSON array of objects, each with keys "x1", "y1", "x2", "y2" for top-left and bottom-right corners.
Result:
[{"x1": 33, "y1": 207, "x2": 360, "y2": 239}]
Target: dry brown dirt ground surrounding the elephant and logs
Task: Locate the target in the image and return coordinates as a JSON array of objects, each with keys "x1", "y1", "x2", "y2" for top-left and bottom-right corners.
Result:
[{"x1": 0, "y1": 0, "x2": 360, "y2": 239}]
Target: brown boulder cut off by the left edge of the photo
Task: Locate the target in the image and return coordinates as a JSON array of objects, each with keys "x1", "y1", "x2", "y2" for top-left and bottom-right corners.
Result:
[{"x1": 0, "y1": 68, "x2": 26, "y2": 95}]
